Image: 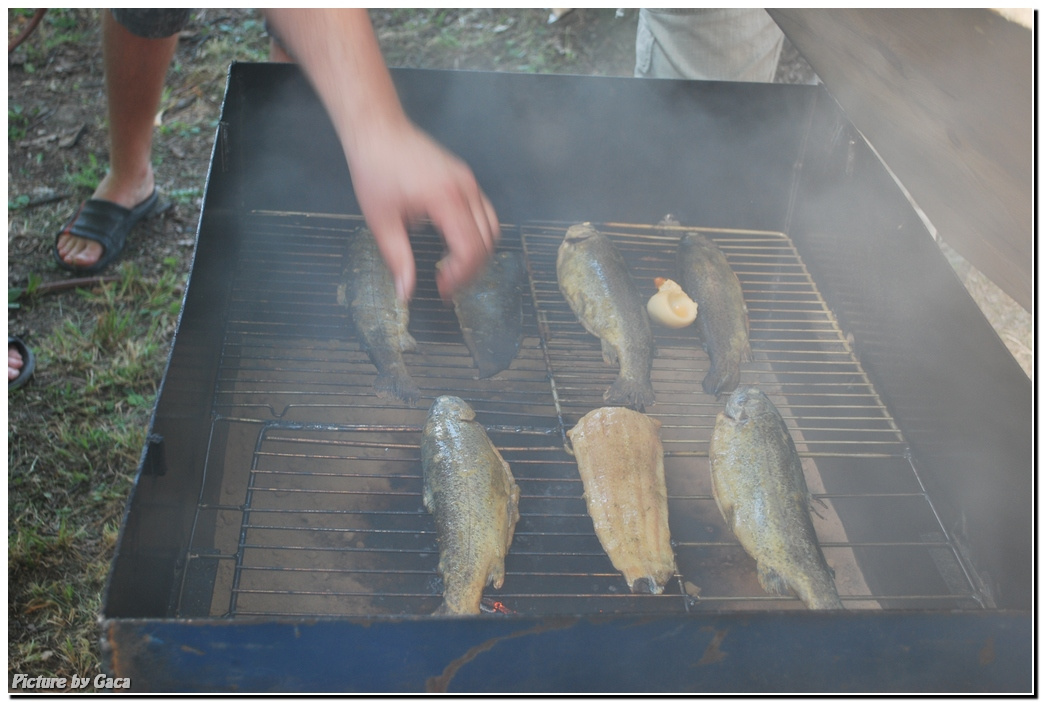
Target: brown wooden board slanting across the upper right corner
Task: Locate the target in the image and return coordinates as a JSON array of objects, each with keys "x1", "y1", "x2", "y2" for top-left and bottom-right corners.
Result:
[{"x1": 769, "y1": 9, "x2": 1034, "y2": 312}]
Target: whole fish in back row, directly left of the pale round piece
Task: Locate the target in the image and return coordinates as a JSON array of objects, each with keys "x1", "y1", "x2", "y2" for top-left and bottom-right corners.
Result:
[{"x1": 557, "y1": 222, "x2": 655, "y2": 410}]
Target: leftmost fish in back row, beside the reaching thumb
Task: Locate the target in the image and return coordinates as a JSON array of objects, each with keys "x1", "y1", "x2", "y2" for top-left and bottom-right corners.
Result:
[{"x1": 337, "y1": 227, "x2": 420, "y2": 407}]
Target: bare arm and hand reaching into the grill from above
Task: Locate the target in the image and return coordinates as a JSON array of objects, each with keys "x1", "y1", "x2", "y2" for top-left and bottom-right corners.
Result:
[{"x1": 264, "y1": 8, "x2": 499, "y2": 299}]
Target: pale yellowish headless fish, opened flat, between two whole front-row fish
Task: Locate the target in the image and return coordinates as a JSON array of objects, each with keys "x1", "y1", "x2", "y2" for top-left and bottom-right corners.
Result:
[{"x1": 567, "y1": 407, "x2": 676, "y2": 595}]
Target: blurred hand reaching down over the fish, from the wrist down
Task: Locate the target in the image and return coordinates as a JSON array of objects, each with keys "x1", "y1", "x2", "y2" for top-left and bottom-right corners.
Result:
[{"x1": 347, "y1": 119, "x2": 500, "y2": 300}]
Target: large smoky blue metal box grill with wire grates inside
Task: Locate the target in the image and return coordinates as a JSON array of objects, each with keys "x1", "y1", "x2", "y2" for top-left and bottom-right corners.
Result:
[{"x1": 102, "y1": 64, "x2": 1033, "y2": 692}]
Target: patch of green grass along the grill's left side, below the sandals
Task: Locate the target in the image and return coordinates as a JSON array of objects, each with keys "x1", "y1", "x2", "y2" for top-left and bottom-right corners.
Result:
[{"x1": 7, "y1": 264, "x2": 184, "y2": 687}]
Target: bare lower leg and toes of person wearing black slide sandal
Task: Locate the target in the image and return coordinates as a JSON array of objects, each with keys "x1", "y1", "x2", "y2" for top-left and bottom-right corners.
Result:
[{"x1": 57, "y1": 10, "x2": 177, "y2": 267}]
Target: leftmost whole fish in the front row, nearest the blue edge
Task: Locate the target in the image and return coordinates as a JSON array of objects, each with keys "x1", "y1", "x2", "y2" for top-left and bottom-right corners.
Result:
[{"x1": 421, "y1": 395, "x2": 521, "y2": 615}]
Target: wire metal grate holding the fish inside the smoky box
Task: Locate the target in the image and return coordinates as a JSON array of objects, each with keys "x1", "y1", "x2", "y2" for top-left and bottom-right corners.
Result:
[{"x1": 179, "y1": 212, "x2": 981, "y2": 617}]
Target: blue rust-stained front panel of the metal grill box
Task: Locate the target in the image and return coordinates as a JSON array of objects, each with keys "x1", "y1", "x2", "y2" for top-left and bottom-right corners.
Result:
[{"x1": 104, "y1": 611, "x2": 1033, "y2": 694}]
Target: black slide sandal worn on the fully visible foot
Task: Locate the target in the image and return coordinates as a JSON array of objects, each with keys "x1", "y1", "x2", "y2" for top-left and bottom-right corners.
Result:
[{"x1": 53, "y1": 190, "x2": 159, "y2": 274}]
